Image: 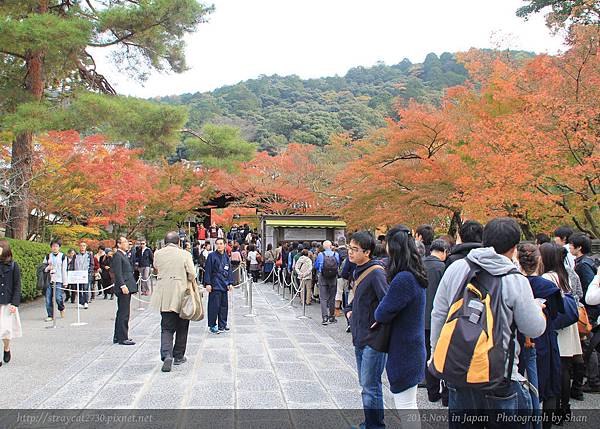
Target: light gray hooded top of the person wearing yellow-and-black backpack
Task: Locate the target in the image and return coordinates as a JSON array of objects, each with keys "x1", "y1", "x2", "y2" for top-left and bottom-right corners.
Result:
[{"x1": 431, "y1": 247, "x2": 546, "y2": 380}]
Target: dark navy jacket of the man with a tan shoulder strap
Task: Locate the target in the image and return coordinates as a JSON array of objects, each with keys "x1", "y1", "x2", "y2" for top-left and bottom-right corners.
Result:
[{"x1": 345, "y1": 260, "x2": 388, "y2": 347}]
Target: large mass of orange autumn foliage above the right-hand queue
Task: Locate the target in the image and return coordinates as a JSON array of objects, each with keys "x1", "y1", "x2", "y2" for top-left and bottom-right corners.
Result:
[{"x1": 331, "y1": 27, "x2": 600, "y2": 237}]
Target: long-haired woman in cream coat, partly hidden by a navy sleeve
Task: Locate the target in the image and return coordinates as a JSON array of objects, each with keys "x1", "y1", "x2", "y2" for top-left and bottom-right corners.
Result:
[{"x1": 540, "y1": 243, "x2": 583, "y2": 417}]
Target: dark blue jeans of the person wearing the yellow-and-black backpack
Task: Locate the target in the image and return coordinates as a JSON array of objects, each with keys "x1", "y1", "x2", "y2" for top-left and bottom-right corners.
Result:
[{"x1": 448, "y1": 381, "x2": 533, "y2": 429}]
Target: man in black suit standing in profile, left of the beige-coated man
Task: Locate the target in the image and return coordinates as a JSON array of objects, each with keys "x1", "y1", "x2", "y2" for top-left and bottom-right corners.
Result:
[{"x1": 110, "y1": 237, "x2": 137, "y2": 346}]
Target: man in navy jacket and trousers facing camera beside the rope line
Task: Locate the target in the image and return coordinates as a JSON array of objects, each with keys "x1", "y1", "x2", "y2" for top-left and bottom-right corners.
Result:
[{"x1": 204, "y1": 238, "x2": 234, "y2": 334}]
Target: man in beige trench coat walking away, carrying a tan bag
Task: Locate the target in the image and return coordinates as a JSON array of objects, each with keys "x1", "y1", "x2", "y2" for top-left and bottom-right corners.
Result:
[{"x1": 150, "y1": 231, "x2": 196, "y2": 372}]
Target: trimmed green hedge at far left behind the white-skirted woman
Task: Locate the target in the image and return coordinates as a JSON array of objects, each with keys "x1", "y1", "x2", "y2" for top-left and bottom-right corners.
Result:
[{"x1": 7, "y1": 238, "x2": 50, "y2": 301}]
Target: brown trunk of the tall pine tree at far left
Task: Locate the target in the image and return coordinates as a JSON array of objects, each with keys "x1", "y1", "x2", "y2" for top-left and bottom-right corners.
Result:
[{"x1": 6, "y1": 0, "x2": 48, "y2": 240}]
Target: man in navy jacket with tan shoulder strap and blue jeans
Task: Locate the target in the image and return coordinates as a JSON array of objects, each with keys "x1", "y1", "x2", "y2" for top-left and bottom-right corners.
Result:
[{"x1": 345, "y1": 231, "x2": 388, "y2": 428}]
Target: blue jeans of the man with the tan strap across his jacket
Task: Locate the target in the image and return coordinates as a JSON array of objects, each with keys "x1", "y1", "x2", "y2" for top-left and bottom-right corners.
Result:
[{"x1": 354, "y1": 346, "x2": 387, "y2": 429}]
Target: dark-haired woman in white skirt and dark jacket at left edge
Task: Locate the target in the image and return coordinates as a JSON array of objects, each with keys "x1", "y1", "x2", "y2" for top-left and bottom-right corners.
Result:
[{"x1": 0, "y1": 240, "x2": 22, "y2": 366}]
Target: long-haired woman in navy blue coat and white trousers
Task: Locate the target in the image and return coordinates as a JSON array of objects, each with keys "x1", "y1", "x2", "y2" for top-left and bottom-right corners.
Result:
[{"x1": 375, "y1": 225, "x2": 427, "y2": 428}]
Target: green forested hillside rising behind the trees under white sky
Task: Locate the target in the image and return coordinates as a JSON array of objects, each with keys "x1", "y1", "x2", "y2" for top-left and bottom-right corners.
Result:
[{"x1": 160, "y1": 52, "x2": 529, "y2": 157}]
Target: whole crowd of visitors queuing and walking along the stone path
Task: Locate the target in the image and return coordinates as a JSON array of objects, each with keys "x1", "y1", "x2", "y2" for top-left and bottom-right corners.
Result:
[{"x1": 0, "y1": 218, "x2": 600, "y2": 428}]
